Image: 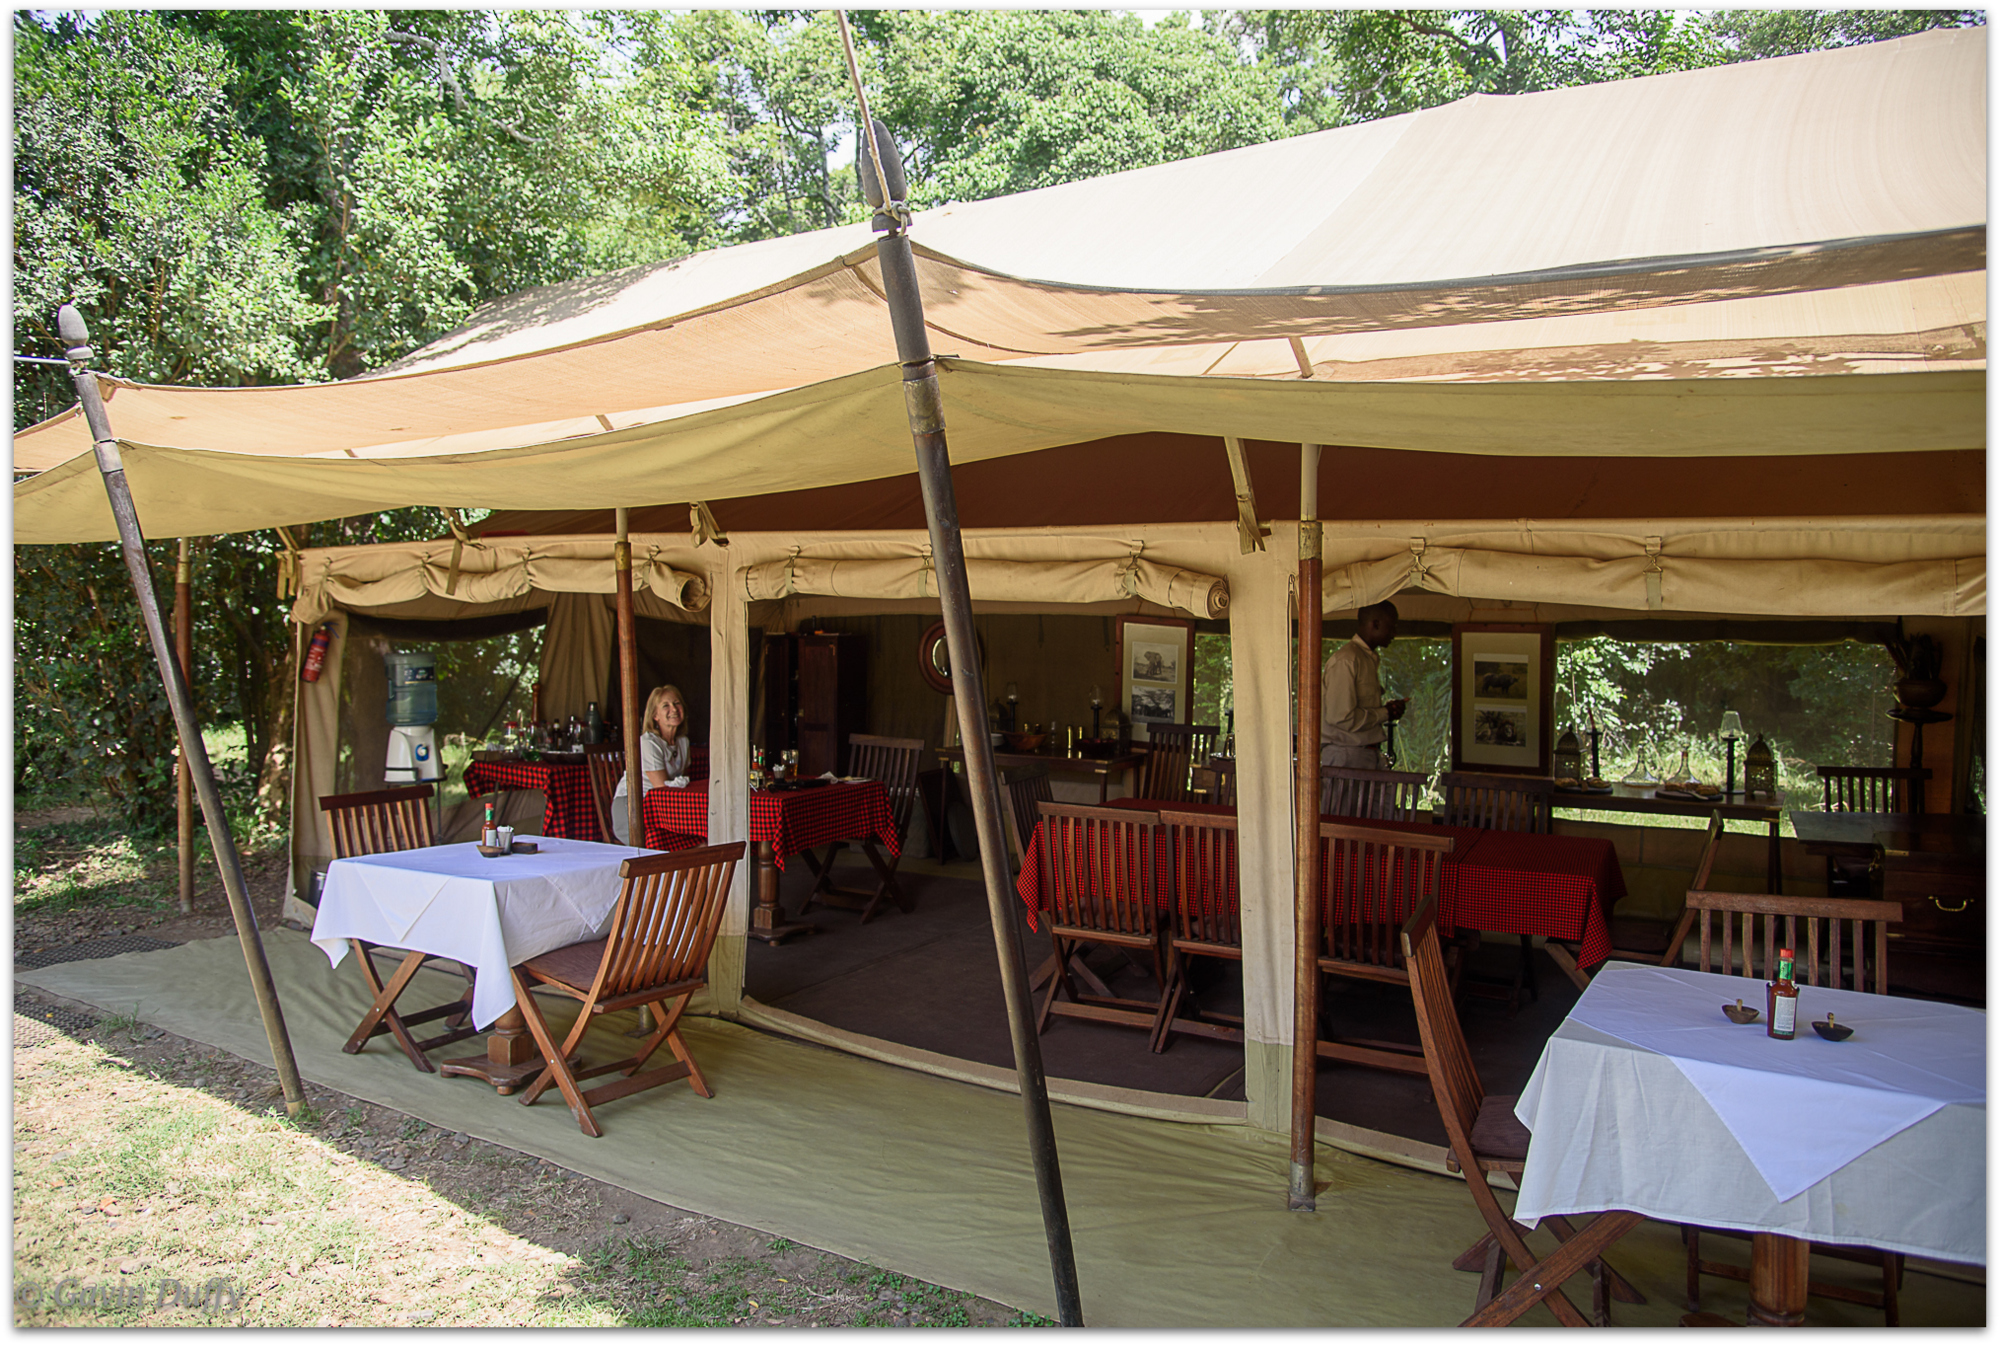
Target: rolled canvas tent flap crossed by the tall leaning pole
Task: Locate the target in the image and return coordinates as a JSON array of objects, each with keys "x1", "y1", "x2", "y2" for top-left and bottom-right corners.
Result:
[{"x1": 744, "y1": 552, "x2": 1230, "y2": 618}]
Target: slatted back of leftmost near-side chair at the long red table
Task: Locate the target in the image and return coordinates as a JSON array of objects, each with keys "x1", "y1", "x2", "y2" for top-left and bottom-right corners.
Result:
[{"x1": 1036, "y1": 803, "x2": 1160, "y2": 935}]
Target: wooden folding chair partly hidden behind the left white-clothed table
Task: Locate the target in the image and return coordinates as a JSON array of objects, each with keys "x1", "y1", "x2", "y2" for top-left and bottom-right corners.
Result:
[{"x1": 320, "y1": 785, "x2": 478, "y2": 1075}]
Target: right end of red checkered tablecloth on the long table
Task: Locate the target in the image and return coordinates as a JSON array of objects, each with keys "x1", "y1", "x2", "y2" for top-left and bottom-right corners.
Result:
[{"x1": 1452, "y1": 831, "x2": 1626, "y2": 967}]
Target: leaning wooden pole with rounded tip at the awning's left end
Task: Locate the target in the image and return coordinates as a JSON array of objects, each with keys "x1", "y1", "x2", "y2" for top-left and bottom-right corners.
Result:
[{"x1": 56, "y1": 304, "x2": 306, "y2": 1117}]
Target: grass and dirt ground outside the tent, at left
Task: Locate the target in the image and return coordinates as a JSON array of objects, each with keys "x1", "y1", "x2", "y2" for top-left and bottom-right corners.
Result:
[{"x1": 14, "y1": 815, "x2": 1052, "y2": 1327}]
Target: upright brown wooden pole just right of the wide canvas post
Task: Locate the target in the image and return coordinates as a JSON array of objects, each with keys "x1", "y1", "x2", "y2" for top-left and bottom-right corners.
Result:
[{"x1": 1286, "y1": 444, "x2": 1320, "y2": 1209}]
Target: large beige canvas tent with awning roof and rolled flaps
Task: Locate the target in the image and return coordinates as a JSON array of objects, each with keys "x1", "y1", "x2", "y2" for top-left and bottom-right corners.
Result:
[{"x1": 14, "y1": 30, "x2": 1986, "y2": 1129}]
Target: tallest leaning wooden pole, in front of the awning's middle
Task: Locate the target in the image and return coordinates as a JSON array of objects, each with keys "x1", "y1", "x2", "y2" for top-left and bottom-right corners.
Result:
[{"x1": 836, "y1": 10, "x2": 1084, "y2": 1327}]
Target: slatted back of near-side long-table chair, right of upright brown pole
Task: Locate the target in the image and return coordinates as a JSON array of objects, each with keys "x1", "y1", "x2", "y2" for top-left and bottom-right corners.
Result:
[{"x1": 1320, "y1": 823, "x2": 1456, "y2": 971}]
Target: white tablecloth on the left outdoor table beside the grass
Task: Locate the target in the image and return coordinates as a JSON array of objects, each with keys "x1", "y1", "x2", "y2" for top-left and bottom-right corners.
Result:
[{"x1": 312, "y1": 837, "x2": 650, "y2": 1027}]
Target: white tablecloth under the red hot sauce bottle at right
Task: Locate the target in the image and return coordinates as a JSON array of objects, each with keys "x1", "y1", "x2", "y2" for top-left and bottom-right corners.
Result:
[{"x1": 1516, "y1": 963, "x2": 1986, "y2": 1265}]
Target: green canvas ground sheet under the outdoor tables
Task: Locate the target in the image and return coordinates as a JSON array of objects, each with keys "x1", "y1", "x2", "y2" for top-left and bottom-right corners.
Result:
[{"x1": 18, "y1": 929, "x2": 1984, "y2": 1329}]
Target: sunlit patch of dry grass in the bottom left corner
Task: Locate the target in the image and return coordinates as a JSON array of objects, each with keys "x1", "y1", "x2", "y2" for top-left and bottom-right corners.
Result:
[{"x1": 14, "y1": 1039, "x2": 620, "y2": 1327}]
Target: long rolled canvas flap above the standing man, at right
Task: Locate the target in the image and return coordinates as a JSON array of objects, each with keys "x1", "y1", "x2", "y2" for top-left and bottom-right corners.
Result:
[{"x1": 1320, "y1": 518, "x2": 1986, "y2": 616}]
